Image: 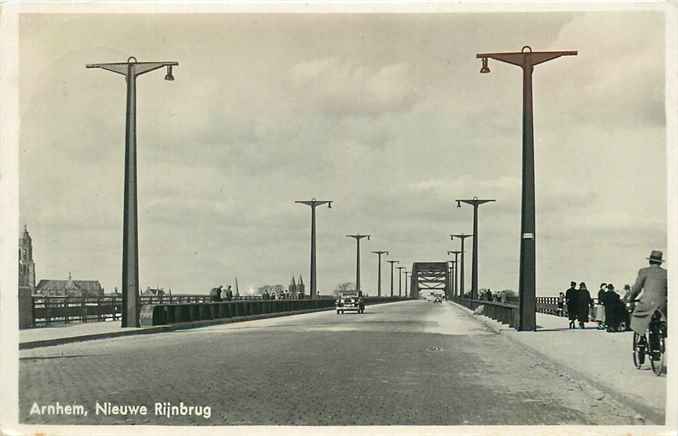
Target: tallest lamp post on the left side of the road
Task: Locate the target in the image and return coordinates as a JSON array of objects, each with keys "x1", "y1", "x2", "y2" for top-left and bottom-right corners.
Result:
[{"x1": 86, "y1": 56, "x2": 179, "y2": 327}]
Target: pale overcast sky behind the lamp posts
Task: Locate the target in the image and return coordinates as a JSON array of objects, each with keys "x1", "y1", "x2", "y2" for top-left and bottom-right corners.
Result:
[{"x1": 20, "y1": 12, "x2": 666, "y2": 295}]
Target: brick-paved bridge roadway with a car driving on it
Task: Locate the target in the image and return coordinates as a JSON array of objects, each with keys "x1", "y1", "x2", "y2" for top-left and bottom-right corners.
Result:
[{"x1": 20, "y1": 300, "x2": 633, "y2": 425}]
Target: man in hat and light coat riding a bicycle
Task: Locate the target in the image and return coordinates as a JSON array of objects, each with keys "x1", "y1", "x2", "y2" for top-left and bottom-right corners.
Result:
[{"x1": 626, "y1": 250, "x2": 668, "y2": 335}]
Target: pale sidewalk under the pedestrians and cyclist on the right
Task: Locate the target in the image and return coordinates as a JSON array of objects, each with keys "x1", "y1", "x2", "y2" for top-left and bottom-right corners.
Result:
[{"x1": 452, "y1": 303, "x2": 666, "y2": 422}]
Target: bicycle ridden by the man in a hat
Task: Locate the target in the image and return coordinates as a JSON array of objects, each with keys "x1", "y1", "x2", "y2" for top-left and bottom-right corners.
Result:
[{"x1": 633, "y1": 304, "x2": 666, "y2": 376}]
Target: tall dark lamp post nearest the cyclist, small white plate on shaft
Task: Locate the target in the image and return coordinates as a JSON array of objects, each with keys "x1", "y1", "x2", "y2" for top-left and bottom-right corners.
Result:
[{"x1": 476, "y1": 45, "x2": 577, "y2": 331}]
